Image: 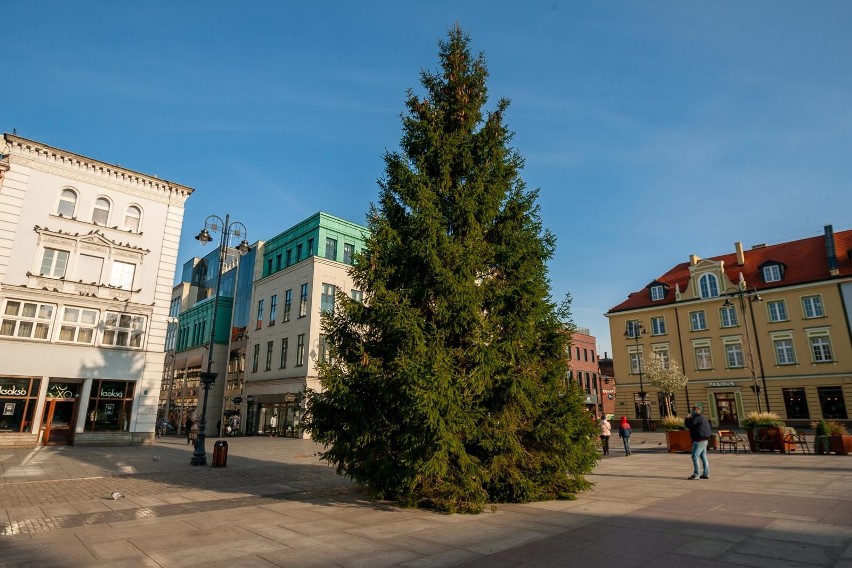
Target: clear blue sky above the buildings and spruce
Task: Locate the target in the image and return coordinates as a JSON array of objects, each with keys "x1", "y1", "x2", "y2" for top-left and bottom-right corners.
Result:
[{"x1": 6, "y1": 0, "x2": 852, "y2": 352}]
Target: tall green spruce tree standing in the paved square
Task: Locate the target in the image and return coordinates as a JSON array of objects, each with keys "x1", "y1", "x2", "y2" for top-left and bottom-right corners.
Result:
[{"x1": 307, "y1": 27, "x2": 597, "y2": 512}]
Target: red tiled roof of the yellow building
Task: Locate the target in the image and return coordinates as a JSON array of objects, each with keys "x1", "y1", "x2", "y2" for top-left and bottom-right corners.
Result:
[{"x1": 608, "y1": 230, "x2": 852, "y2": 313}]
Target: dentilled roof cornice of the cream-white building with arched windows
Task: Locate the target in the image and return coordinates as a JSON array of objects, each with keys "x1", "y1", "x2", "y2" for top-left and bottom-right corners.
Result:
[{"x1": 0, "y1": 134, "x2": 194, "y2": 202}]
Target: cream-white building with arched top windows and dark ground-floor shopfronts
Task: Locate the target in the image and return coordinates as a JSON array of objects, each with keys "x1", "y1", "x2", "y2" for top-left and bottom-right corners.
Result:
[{"x1": 0, "y1": 134, "x2": 193, "y2": 446}]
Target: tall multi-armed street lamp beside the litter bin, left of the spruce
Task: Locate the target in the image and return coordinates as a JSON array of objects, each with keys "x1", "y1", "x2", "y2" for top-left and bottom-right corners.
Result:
[{"x1": 189, "y1": 215, "x2": 251, "y2": 465}]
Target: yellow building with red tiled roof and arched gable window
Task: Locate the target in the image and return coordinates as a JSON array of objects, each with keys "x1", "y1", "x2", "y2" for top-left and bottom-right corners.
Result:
[{"x1": 606, "y1": 225, "x2": 852, "y2": 427}]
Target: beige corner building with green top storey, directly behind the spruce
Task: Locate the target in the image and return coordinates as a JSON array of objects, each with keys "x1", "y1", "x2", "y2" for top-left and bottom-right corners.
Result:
[{"x1": 243, "y1": 212, "x2": 367, "y2": 437}]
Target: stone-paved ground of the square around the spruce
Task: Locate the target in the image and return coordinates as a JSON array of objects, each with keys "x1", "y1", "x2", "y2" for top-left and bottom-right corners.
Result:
[{"x1": 0, "y1": 433, "x2": 852, "y2": 568}]
